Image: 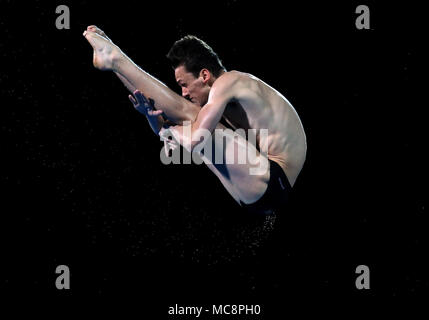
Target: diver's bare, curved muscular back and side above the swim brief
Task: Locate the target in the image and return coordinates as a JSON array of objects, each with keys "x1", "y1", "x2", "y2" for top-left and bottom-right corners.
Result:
[{"x1": 217, "y1": 71, "x2": 307, "y2": 185}]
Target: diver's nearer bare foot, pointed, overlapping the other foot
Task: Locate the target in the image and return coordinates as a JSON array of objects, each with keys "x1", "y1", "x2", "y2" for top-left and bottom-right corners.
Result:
[{"x1": 83, "y1": 30, "x2": 123, "y2": 70}]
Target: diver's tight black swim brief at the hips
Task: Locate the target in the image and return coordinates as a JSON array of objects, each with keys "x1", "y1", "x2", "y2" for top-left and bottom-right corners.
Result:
[{"x1": 242, "y1": 160, "x2": 292, "y2": 214}]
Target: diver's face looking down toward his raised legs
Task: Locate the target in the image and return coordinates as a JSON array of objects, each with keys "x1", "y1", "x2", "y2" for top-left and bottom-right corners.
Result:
[{"x1": 174, "y1": 65, "x2": 210, "y2": 107}]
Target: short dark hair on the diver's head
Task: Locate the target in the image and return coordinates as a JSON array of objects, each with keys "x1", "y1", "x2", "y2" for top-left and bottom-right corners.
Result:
[{"x1": 167, "y1": 35, "x2": 225, "y2": 78}]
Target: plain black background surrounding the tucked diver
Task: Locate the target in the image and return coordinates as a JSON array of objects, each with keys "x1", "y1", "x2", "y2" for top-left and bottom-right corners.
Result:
[{"x1": 0, "y1": 1, "x2": 429, "y2": 319}]
